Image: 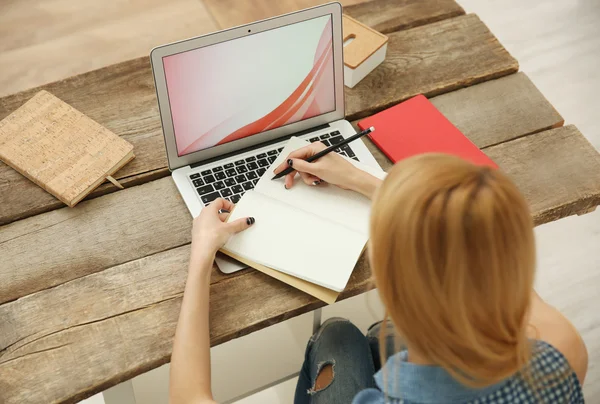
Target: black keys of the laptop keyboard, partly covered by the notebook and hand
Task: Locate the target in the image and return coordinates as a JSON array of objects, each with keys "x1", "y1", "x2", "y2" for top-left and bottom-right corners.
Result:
[{"x1": 190, "y1": 130, "x2": 358, "y2": 206}]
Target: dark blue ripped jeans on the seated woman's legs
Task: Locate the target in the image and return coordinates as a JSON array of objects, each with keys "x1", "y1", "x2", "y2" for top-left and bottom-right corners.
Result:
[{"x1": 294, "y1": 317, "x2": 394, "y2": 404}]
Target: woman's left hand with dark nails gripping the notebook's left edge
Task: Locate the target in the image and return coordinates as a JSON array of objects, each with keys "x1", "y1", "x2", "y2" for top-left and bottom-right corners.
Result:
[{"x1": 192, "y1": 199, "x2": 254, "y2": 256}]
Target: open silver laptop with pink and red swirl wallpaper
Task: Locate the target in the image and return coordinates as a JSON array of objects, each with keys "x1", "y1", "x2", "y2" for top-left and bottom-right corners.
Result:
[{"x1": 150, "y1": 3, "x2": 379, "y2": 273}]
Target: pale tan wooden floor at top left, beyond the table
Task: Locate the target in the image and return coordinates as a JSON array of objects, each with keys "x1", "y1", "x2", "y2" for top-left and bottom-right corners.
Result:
[{"x1": 0, "y1": 0, "x2": 218, "y2": 96}]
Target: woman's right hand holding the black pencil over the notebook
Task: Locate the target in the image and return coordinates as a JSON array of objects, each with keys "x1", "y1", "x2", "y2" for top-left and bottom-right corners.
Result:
[{"x1": 274, "y1": 142, "x2": 381, "y2": 198}]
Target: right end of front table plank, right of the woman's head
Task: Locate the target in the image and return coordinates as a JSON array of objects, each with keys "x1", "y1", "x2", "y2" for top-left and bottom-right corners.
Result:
[{"x1": 485, "y1": 125, "x2": 600, "y2": 225}]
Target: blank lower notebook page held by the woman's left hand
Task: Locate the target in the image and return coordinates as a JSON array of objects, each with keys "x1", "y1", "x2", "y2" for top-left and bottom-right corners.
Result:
[{"x1": 224, "y1": 191, "x2": 367, "y2": 292}]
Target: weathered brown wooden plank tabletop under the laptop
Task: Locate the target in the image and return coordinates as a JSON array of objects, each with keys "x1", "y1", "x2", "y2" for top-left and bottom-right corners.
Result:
[{"x1": 0, "y1": 0, "x2": 600, "y2": 404}]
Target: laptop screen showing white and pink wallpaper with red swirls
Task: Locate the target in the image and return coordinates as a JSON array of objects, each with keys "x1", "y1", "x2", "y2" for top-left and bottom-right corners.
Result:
[{"x1": 163, "y1": 15, "x2": 335, "y2": 156}]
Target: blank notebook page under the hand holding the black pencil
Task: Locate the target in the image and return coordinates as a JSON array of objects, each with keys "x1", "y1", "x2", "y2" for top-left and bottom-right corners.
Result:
[{"x1": 255, "y1": 137, "x2": 385, "y2": 235}]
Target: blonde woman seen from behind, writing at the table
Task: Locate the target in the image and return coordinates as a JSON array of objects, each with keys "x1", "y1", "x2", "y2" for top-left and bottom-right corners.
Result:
[{"x1": 170, "y1": 143, "x2": 587, "y2": 404}]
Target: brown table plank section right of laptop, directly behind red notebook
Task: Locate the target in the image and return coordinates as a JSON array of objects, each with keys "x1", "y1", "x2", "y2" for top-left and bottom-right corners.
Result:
[{"x1": 345, "y1": 14, "x2": 519, "y2": 120}]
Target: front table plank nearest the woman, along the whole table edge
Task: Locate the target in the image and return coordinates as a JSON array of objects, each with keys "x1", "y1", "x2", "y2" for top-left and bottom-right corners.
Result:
[{"x1": 0, "y1": 126, "x2": 600, "y2": 403}]
